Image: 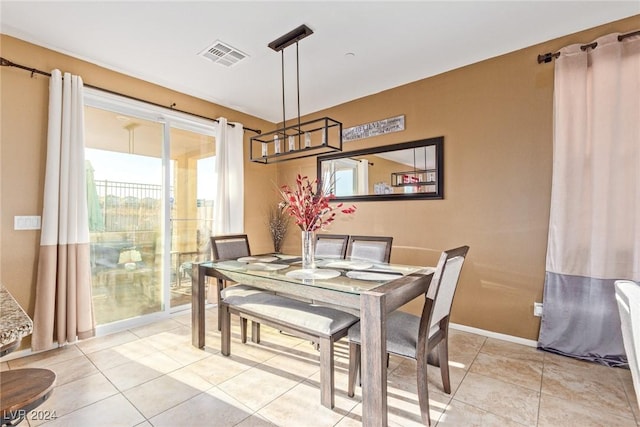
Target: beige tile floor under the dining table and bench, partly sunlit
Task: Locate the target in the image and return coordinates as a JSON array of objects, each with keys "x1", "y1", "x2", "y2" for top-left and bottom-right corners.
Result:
[{"x1": 1, "y1": 308, "x2": 640, "y2": 427}]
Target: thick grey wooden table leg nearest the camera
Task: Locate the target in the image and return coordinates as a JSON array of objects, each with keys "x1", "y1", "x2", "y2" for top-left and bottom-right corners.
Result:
[{"x1": 360, "y1": 292, "x2": 387, "y2": 427}]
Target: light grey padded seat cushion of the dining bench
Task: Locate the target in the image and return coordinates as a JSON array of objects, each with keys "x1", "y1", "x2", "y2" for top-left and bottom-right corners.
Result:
[{"x1": 223, "y1": 286, "x2": 359, "y2": 337}]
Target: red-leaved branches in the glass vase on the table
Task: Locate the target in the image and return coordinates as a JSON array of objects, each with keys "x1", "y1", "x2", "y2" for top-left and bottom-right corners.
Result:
[{"x1": 280, "y1": 174, "x2": 356, "y2": 231}]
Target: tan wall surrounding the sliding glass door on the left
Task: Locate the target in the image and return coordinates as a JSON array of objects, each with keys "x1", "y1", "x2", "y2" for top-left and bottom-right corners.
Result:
[{"x1": 0, "y1": 35, "x2": 276, "y2": 347}]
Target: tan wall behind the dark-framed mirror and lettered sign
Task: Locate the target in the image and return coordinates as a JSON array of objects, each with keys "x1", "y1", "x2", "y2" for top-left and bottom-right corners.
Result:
[{"x1": 278, "y1": 15, "x2": 640, "y2": 340}]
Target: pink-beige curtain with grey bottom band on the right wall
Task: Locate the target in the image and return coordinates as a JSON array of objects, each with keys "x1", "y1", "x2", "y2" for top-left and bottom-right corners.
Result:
[{"x1": 538, "y1": 34, "x2": 640, "y2": 366}]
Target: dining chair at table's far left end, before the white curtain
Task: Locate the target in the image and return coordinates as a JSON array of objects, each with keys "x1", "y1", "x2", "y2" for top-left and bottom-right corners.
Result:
[{"x1": 211, "y1": 234, "x2": 260, "y2": 336}]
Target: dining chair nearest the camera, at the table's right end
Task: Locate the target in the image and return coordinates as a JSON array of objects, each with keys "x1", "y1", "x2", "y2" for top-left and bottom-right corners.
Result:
[{"x1": 348, "y1": 246, "x2": 469, "y2": 425}]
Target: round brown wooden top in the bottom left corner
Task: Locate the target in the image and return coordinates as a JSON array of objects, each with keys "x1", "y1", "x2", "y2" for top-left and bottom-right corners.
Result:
[{"x1": 0, "y1": 368, "x2": 56, "y2": 426}]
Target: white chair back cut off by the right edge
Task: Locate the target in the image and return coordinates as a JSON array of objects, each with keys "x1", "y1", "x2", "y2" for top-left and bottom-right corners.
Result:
[{"x1": 615, "y1": 280, "x2": 640, "y2": 407}]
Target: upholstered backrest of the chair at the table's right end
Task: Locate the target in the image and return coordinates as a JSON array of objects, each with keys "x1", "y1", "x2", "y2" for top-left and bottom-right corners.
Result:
[{"x1": 419, "y1": 246, "x2": 469, "y2": 338}]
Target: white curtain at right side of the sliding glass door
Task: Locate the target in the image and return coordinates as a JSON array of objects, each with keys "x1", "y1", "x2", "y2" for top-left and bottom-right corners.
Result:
[{"x1": 213, "y1": 117, "x2": 244, "y2": 235}]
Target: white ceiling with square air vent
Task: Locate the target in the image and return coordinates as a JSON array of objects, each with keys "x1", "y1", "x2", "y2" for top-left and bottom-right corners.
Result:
[{"x1": 0, "y1": 0, "x2": 640, "y2": 122}]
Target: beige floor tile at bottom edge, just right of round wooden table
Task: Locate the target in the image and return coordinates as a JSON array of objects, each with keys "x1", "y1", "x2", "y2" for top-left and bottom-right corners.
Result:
[{"x1": 38, "y1": 394, "x2": 146, "y2": 427}]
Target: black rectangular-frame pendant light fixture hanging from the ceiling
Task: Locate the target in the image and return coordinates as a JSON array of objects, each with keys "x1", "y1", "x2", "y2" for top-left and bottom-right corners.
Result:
[{"x1": 249, "y1": 25, "x2": 342, "y2": 164}]
